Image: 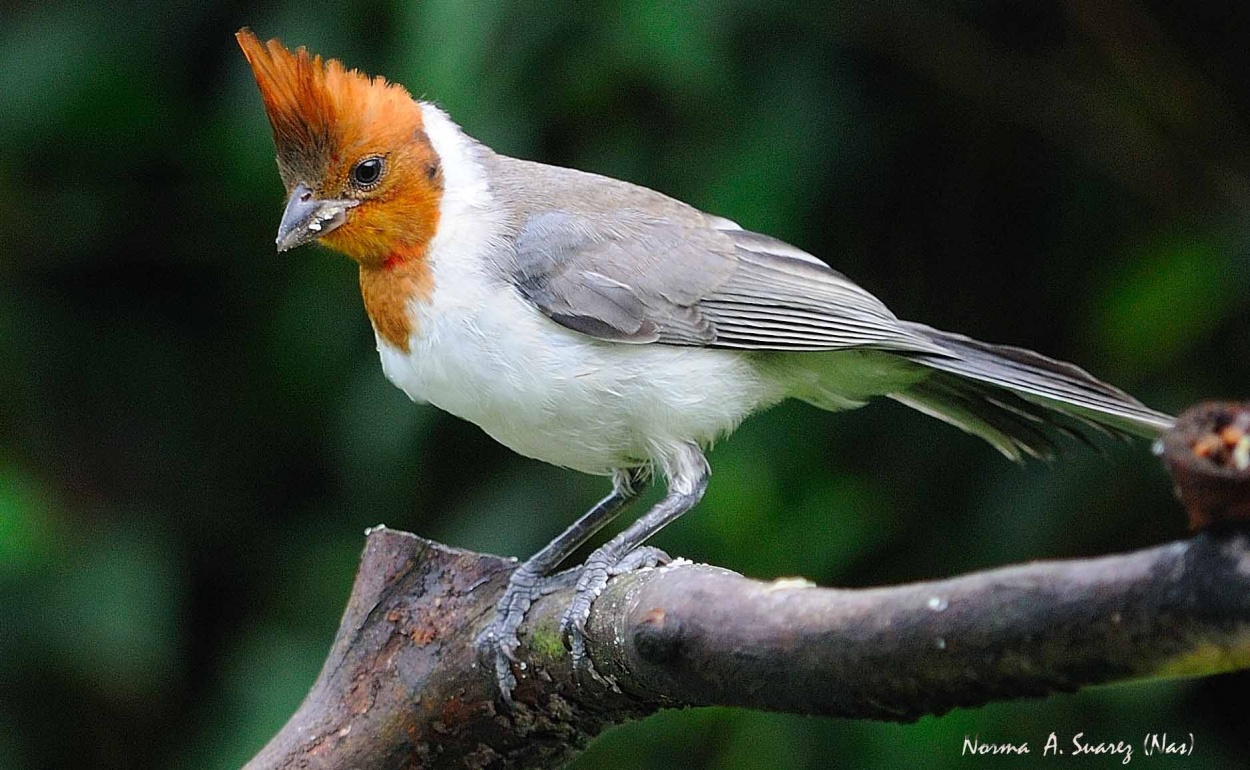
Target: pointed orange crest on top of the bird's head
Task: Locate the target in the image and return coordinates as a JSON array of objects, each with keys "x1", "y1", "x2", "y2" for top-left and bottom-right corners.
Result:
[{"x1": 235, "y1": 28, "x2": 421, "y2": 186}]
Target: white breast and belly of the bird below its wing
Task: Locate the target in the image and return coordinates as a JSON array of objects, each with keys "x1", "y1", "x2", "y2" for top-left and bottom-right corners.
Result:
[{"x1": 379, "y1": 282, "x2": 784, "y2": 474}]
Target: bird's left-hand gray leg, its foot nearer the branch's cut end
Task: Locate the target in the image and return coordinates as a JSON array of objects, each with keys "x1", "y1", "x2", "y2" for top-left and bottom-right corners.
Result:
[{"x1": 478, "y1": 470, "x2": 643, "y2": 703}]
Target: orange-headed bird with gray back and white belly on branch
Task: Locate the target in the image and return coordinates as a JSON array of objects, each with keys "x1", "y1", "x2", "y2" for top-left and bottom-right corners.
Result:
[{"x1": 236, "y1": 28, "x2": 1173, "y2": 703}]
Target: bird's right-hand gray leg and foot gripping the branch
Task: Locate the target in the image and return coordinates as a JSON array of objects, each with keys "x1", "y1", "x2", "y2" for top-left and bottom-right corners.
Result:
[{"x1": 561, "y1": 445, "x2": 710, "y2": 675}]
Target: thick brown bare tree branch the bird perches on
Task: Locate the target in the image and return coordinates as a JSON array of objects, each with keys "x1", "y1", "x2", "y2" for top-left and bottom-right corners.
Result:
[{"x1": 246, "y1": 405, "x2": 1250, "y2": 770}]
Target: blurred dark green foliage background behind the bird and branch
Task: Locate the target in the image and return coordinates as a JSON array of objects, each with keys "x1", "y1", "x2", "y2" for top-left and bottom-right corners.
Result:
[{"x1": 0, "y1": 0, "x2": 1250, "y2": 770}]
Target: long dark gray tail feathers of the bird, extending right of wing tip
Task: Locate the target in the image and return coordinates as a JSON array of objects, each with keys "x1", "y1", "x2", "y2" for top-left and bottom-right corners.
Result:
[{"x1": 890, "y1": 324, "x2": 1173, "y2": 460}]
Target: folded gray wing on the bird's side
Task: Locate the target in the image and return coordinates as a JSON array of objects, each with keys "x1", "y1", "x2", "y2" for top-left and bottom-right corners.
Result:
[{"x1": 514, "y1": 210, "x2": 945, "y2": 355}]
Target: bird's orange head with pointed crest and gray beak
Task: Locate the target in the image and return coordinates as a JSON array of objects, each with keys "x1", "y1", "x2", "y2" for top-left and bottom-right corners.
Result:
[{"x1": 236, "y1": 29, "x2": 443, "y2": 268}]
